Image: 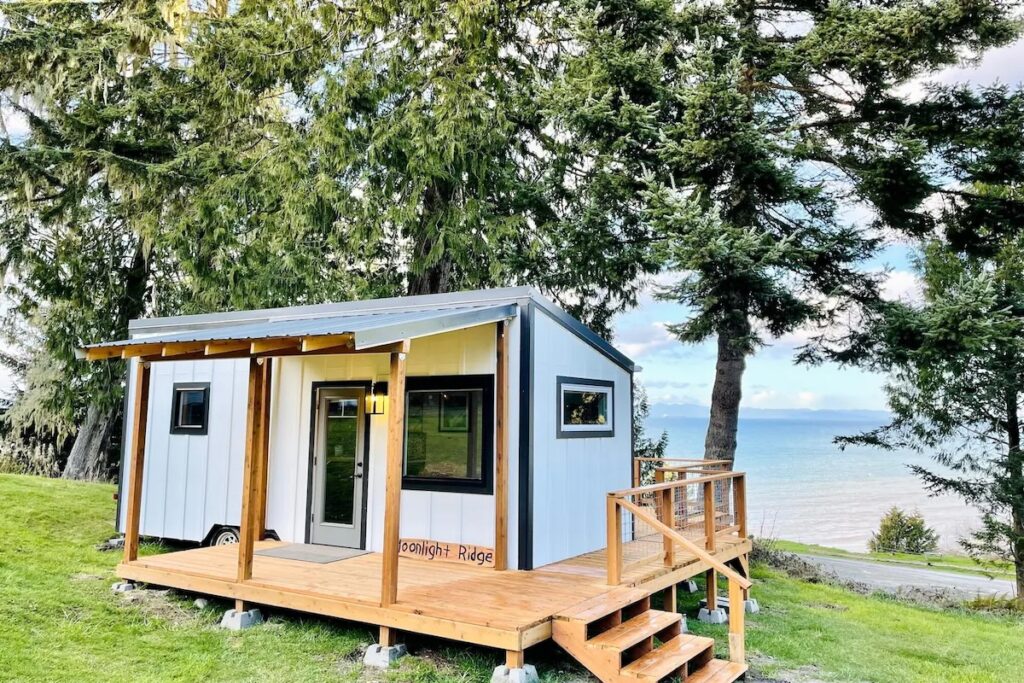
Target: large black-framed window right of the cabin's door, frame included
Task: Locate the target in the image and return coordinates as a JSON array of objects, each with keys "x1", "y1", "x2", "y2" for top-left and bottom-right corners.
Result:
[{"x1": 402, "y1": 376, "x2": 494, "y2": 494}]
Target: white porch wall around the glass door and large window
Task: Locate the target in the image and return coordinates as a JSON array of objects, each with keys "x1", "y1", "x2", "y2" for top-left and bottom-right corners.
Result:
[{"x1": 267, "y1": 321, "x2": 519, "y2": 561}]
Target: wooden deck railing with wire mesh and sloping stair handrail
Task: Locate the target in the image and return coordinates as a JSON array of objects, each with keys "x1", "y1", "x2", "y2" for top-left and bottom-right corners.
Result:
[{"x1": 607, "y1": 472, "x2": 751, "y2": 663}]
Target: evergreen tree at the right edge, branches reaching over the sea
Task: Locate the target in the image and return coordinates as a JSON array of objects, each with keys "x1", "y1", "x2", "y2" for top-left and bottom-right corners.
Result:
[{"x1": 824, "y1": 87, "x2": 1024, "y2": 599}]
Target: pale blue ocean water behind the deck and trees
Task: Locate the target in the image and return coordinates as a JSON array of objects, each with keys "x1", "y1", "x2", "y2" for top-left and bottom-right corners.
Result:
[{"x1": 646, "y1": 417, "x2": 978, "y2": 551}]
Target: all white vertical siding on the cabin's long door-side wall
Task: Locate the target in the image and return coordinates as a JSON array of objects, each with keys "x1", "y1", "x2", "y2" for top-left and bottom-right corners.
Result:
[{"x1": 121, "y1": 319, "x2": 520, "y2": 568}]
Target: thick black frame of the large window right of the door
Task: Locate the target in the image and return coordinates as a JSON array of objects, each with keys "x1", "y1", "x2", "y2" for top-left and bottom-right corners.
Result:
[{"x1": 401, "y1": 375, "x2": 495, "y2": 496}]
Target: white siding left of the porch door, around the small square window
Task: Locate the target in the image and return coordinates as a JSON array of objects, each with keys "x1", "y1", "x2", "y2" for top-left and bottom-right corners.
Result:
[{"x1": 118, "y1": 360, "x2": 249, "y2": 541}]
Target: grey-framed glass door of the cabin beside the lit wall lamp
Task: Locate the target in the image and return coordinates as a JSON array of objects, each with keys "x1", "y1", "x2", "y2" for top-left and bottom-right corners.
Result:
[{"x1": 309, "y1": 388, "x2": 366, "y2": 548}]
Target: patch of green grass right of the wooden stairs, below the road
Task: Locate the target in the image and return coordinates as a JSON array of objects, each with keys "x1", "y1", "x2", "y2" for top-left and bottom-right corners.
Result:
[{"x1": 680, "y1": 567, "x2": 1024, "y2": 683}]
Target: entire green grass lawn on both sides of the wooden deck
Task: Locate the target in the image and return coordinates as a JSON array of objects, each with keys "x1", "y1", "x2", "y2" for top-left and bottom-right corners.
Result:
[{"x1": 6, "y1": 475, "x2": 1024, "y2": 683}]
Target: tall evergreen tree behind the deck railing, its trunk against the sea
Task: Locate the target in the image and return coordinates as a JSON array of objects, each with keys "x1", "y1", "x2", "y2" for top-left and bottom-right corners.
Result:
[{"x1": 553, "y1": 0, "x2": 1017, "y2": 460}]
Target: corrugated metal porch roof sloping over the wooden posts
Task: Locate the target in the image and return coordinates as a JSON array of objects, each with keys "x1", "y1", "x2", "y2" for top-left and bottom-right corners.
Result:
[{"x1": 85, "y1": 304, "x2": 518, "y2": 349}]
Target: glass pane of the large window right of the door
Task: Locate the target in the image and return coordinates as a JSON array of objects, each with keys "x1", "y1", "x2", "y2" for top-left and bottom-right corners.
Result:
[{"x1": 404, "y1": 389, "x2": 483, "y2": 481}]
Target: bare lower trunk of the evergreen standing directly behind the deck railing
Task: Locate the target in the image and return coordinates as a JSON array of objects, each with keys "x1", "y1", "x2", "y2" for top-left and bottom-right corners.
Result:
[{"x1": 705, "y1": 325, "x2": 750, "y2": 470}]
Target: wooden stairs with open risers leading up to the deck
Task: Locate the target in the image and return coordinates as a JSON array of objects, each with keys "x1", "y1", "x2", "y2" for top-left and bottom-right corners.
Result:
[{"x1": 552, "y1": 588, "x2": 746, "y2": 683}]
